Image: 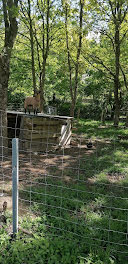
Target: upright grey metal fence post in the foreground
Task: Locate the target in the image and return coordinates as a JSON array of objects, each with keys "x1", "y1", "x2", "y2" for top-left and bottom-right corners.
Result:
[{"x1": 12, "y1": 138, "x2": 19, "y2": 235}]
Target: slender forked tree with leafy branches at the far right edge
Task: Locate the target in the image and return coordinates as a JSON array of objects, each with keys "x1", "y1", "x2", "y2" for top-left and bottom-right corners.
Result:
[{"x1": 88, "y1": 0, "x2": 128, "y2": 126}]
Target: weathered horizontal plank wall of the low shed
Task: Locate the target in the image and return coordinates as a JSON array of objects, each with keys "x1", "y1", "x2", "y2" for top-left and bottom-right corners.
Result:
[{"x1": 20, "y1": 116, "x2": 69, "y2": 151}]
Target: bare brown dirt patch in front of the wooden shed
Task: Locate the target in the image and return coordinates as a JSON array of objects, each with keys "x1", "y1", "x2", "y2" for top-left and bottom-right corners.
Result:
[{"x1": 0, "y1": 134, "x2": 124, "y2": 215}]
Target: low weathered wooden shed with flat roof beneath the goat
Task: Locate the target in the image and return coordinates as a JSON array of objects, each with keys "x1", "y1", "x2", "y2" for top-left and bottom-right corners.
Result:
[{"x1": 7, "y1": 111, "x2": 72, "y2": 151}]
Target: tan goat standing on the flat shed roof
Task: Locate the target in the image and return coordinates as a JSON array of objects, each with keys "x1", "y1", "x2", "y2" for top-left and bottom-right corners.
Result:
[{"x1": 24, "y1": 92, "x2": 40, "y2": 114}]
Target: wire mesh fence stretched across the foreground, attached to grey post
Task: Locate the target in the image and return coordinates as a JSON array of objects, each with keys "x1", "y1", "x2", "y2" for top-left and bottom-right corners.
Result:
[{"x1": 0, "y1": 109, "x2": 128, "y2": 259}]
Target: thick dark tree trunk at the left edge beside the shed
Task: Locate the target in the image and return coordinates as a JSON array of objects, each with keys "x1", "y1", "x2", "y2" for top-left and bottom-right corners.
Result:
[{"x1": 0, "y1": 0, "x2": 18, "y2": 153}]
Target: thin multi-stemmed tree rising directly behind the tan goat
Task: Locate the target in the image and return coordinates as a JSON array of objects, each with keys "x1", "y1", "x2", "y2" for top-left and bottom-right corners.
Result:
[{"x1": 20, "y1": 0, "x2": 54, "y2": 111}]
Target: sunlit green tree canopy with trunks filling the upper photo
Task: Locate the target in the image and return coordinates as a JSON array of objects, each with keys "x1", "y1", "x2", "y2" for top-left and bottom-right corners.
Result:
[{"x1": 0, "y1": 0, "x2": 128, "y2": 125}]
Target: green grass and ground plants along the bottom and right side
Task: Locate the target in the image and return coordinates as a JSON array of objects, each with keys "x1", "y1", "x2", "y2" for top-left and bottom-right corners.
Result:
[{"x1": 0, "y1": 120, "x2": 128, "y2": 264}]
